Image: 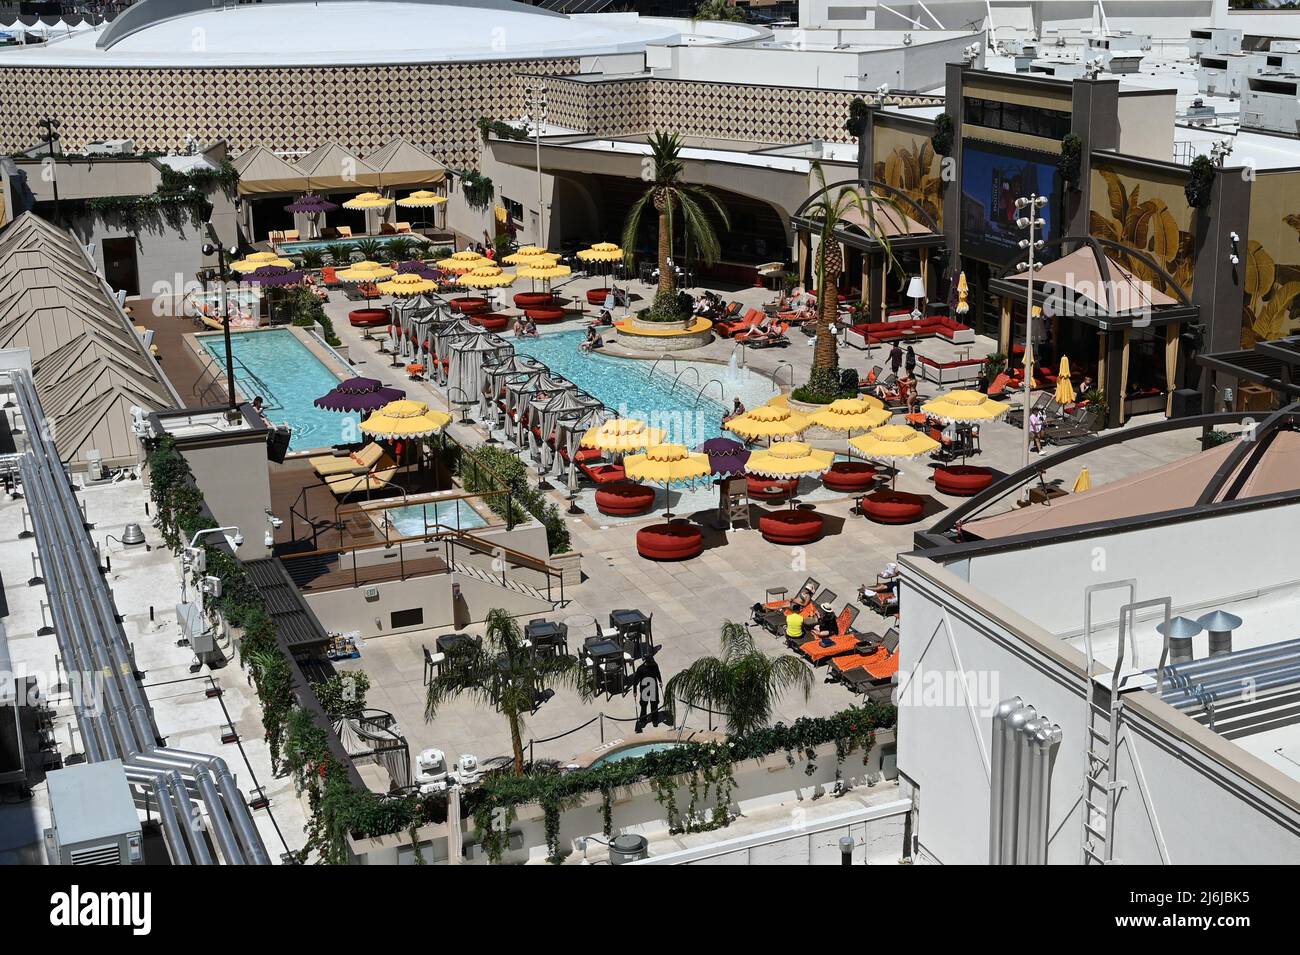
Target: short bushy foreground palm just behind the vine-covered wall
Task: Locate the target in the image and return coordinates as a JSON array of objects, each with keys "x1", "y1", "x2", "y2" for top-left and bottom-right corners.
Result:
[{"x1": 664, "y1": 620, "x2": 813, "y2": 735}]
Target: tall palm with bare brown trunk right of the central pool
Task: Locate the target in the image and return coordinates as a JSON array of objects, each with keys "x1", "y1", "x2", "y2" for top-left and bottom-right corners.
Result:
[{"x1": 807, "y1": 162, "x2": 898, "y2": 391}]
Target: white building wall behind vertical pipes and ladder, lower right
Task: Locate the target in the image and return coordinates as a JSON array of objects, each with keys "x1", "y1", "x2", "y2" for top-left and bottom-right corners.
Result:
[{"x1": 898, "y1": 548, "x2": 1300, "y2": 864}]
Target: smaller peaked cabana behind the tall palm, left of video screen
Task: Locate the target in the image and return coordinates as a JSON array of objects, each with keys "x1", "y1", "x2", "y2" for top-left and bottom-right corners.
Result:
[{"x1": 790, "y1": 179, "x2": 946, "y2": 321}]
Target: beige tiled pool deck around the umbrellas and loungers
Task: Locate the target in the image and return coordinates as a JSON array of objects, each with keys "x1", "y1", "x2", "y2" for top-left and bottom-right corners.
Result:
[{"x1": 306, "y1": 272, "x2": 1195, "y2": 774}]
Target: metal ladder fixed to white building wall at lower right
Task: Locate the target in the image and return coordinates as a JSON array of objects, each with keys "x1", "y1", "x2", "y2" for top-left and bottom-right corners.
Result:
[{"x1": 1079, "y1": 578, "x2": 1173, "y2": 865}]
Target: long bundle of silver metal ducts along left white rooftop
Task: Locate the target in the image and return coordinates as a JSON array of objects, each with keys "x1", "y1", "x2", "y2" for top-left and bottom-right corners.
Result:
[{"x1": 12, "y1": 372, "x2": 270, "y2": 865}]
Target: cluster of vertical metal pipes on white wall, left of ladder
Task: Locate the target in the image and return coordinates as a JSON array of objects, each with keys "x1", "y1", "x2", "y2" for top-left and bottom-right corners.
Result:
[{"x1": 988, "y1": 696, "x2": 1061, "y2": 865}]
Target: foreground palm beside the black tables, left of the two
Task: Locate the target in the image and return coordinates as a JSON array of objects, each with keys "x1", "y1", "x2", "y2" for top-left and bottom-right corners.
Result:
[{"x1": 424, "y1": 608, "x2": 592, "y2": 776}]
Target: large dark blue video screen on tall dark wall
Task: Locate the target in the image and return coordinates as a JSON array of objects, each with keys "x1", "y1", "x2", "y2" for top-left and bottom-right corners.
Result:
[{"x1": 962, "y1": 139, "x2": 1061, "y2": 265}]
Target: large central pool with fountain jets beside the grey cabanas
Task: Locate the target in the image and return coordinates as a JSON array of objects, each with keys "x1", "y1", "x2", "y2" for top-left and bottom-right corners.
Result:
[{"x1": 511, "y1": 330, "x2": 775, "y2": 447}]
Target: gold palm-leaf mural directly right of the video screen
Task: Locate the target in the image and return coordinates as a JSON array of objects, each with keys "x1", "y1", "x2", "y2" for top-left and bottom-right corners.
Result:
[{"x1": 1088, "y1": 166, "x2": 1195, "y2": 295}]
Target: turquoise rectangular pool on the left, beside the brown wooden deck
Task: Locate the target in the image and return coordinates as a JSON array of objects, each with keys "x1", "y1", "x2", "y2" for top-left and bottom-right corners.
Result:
[{"x1": 199, "y1": 329, "x2": 361, "y2": 451}]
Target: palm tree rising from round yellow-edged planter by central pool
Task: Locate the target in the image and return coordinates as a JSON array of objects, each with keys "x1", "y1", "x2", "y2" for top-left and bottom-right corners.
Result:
[{"x1": 623, "y1": 130, "x2": 731, "y2": 318}]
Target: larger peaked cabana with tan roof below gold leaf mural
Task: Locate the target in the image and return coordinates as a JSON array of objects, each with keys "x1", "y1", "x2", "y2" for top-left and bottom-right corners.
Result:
[{"x1": 988, "y1": 235, "x2": 1200, "y2": 427}]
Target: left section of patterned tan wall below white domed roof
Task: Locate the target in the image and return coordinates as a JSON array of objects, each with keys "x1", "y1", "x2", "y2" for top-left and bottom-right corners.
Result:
[{"x1": 0, "y1": 57, "x2": 579, "y2": 168}]
